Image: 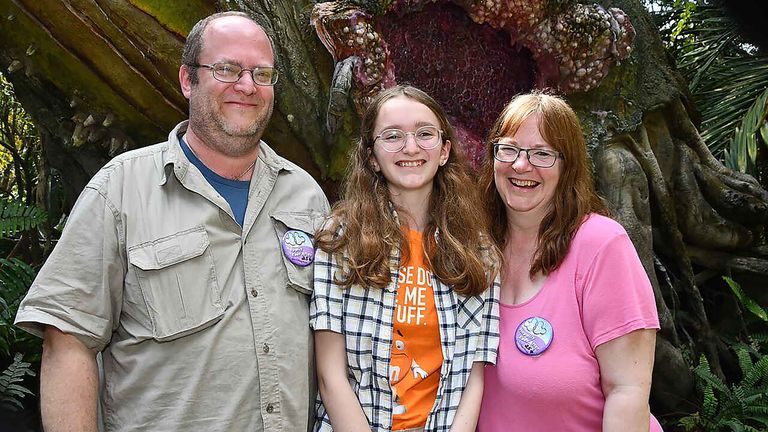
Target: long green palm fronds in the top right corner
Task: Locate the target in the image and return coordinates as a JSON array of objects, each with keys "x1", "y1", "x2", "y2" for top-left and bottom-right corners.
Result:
[{"x1": 648, "y1": 0, "x2": 768, "y2": 179}]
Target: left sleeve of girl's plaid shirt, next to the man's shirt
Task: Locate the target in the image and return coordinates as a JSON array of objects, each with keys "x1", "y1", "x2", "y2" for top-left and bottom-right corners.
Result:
[{"x1": 309, "y1": 248, "x2": 343, "y2": 333}]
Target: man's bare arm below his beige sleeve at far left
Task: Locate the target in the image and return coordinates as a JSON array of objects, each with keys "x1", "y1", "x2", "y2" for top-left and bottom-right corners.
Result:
[{"x1": 40, "y1": 326, "x2": 99, "y2": 432}]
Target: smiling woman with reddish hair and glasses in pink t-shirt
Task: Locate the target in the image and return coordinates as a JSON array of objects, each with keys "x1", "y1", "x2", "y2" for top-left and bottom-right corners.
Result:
[{"x1": 478, "y1": 93, "x2": 661, "y2": 432}]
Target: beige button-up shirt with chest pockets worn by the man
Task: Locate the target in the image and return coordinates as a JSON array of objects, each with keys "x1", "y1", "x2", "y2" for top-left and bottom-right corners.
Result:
[{"x1": 16, "y1": 123, "x2": 329, "y2": 432}]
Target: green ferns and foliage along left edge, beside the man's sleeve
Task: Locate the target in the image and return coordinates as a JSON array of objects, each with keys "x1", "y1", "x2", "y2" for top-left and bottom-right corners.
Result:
[{"x1": 0, "y1": 75, "x2": 57, "y2": 426}]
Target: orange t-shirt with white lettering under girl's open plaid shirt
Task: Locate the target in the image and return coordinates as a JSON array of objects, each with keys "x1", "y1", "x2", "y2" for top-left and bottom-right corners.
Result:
[{"x1": 389, "y1": 228, "x2": 443, "y2": 430}]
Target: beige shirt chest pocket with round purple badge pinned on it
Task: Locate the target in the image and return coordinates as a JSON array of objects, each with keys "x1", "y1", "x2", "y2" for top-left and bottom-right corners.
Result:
[{"x1": 270, "y1": 212, "x2": 322, "y2": 295}]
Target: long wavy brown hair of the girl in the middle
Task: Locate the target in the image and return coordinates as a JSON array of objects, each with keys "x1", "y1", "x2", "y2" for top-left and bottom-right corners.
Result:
[{"x1": 316, "y1": 85, "x2": 500, "y2": 295}]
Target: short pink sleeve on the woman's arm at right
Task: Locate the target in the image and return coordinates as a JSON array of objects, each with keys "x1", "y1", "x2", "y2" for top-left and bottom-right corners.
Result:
[{"x1": 581, "y1": 233, "x2": 659, "y2": 349}]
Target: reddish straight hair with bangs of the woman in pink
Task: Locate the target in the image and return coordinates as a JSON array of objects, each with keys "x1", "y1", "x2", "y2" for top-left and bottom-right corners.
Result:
[{"x1": 480, "y1": 91, "x2": 608, "y2": 277}]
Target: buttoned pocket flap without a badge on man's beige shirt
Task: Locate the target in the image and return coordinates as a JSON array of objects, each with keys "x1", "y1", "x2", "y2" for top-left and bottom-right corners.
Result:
[{"x1": 128, "y1": 225, "x2": 210, "y2": 270}]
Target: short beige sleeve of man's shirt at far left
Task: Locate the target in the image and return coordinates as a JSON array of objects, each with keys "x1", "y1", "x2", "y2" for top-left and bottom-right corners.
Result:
[{"x1": 15, "y1": 186, "x2": 127, "y2": 350}]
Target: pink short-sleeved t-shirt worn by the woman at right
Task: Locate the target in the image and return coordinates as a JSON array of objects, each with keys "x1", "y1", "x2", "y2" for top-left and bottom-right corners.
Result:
[{"x1": 478, "y1": 215, "x2": 661, "y2": 432}]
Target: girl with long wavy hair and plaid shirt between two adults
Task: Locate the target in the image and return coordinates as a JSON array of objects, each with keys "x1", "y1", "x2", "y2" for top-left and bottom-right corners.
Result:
[{"x1": 310, "y1": 86, "x2": 498, "y2": 431}]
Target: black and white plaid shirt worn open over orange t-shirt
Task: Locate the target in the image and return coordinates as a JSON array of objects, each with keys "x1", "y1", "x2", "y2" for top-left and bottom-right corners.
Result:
[{"x1": 310, "y1": 238, "x2": 500, "y2": 432}]
